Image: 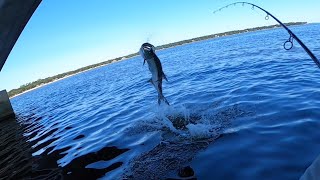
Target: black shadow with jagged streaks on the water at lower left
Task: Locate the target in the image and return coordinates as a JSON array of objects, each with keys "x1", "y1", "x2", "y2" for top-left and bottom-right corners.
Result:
[{"x1": 0, "y1": 118, "x2": 129, "y2": 179}]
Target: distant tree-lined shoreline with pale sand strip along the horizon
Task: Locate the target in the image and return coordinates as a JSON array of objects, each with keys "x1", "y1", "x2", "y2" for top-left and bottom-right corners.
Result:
[{"x1": 8, "y1": 22, "x2": 307, "y2": 99}]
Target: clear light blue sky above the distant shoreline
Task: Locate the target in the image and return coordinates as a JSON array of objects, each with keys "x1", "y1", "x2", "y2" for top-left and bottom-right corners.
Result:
[{"x1": 0, "y1": 0, "x2": 320, "y2": 91}]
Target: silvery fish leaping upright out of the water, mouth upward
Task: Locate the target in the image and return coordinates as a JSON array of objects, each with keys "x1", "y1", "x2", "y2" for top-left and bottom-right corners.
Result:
[{"x1": 139, "y1": 43, "x2": 169, "y2": 105}]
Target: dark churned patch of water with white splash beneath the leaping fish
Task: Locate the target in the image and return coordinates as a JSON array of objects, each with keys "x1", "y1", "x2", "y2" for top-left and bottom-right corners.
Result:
[{"x1": 124, "y1": 104, "x2": 252, "y2": 179}]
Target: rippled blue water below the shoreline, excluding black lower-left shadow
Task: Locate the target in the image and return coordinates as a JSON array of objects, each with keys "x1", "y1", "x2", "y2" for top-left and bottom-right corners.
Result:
[{"x1": 12, "y1": 24, "x2": 320, "y2": 179}]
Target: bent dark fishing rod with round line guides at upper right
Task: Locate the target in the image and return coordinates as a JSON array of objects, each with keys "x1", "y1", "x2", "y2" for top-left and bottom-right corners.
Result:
[{"x1": 213, "y1": 2, "x2": 320, "y2": 68}]
